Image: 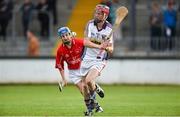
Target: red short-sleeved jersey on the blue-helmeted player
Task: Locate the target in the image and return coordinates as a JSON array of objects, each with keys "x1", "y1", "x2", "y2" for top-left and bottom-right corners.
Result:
[{"x1": 55, "y1": 39, "x2": 84, "y2": 70}]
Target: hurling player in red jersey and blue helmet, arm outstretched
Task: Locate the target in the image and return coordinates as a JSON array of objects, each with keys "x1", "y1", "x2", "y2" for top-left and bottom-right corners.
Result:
[{"x1": 55, "y1": 27, "x2": 108, "y2": 115}]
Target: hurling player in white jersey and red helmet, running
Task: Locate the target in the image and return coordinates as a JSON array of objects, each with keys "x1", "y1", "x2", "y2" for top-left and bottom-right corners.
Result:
[{"x1": 81, "y1": 4, "x2": 113, "y2": 115}]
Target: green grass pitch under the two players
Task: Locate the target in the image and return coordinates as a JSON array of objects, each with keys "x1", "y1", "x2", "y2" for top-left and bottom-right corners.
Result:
[{"x1": 0, "y1": 85, "x2": 180, "y2": 116}]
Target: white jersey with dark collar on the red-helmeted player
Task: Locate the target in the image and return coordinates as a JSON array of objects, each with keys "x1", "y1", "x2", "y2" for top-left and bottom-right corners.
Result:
[{"x1": 82, "y1": 20, "x2": 113, "y2": 60}]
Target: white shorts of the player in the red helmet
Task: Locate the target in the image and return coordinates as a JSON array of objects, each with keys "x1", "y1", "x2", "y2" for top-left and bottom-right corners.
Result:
[{"x1": 80, "y1": 60, "x2": 107, "y2": 77}]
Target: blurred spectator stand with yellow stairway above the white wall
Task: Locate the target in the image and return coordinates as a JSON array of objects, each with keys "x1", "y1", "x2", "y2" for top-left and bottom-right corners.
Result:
[{"x1": 0, "y1": 0, "x2": 180, "y2": 57}]
